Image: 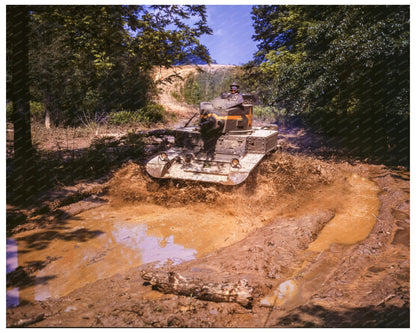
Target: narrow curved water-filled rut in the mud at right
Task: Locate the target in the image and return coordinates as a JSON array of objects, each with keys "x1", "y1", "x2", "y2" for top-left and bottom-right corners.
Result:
[{"x1": 261, "y1": 174, "x2": 380, "y2": 306}]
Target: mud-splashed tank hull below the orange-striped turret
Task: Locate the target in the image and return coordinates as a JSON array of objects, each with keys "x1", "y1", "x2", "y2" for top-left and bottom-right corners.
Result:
[{"x1": 146, "y1": 127, "x2": 278, "y2": 185}]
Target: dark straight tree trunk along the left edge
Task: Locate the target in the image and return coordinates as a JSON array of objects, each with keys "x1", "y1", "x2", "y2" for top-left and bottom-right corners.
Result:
[{"x1": 7, "y1": 5, "x2": 37, "y2": 204}]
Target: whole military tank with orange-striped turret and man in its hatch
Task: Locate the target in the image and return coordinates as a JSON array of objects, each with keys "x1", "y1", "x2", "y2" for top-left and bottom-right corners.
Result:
[{"x1": 146, "y1": 83, "x2": 278, "y2": 185}]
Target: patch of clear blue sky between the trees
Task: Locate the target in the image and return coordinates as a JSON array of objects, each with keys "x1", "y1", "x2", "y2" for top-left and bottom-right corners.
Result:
[{"x1": 200, "y1": 5, "x2": 257, "y2": 65}]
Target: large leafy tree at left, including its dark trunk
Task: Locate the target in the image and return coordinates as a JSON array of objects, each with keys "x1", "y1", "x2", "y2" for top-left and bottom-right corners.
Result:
[{"x1": 6, "y1": 6, "x2": 211, "y2": 203}]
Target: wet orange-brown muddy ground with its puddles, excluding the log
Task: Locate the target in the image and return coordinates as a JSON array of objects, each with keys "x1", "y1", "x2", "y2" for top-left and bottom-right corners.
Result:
[{"x1": 7, "y1": 127, "x2": 410, "y2": 327}]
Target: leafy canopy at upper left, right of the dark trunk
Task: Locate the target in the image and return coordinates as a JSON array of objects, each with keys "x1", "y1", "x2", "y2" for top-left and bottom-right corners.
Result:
[{"x1": 13, "y1": 5, "x2": 212, "y2": 125}]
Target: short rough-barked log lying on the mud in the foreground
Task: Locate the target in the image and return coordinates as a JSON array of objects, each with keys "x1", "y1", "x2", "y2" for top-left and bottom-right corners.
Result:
[{"x1": 141, "y1": 271, "x2": 253, "y2": 308}]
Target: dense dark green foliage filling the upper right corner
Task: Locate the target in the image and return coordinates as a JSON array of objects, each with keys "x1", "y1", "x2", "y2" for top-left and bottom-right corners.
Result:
[{"x1": 246, "y1": 5, "x2": 410, "y2": 165}]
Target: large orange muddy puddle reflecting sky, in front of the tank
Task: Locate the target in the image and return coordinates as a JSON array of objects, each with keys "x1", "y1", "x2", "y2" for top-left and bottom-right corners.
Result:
[{"x1": 7, "y1": 204, "x2": 256, "y2": 306}]
